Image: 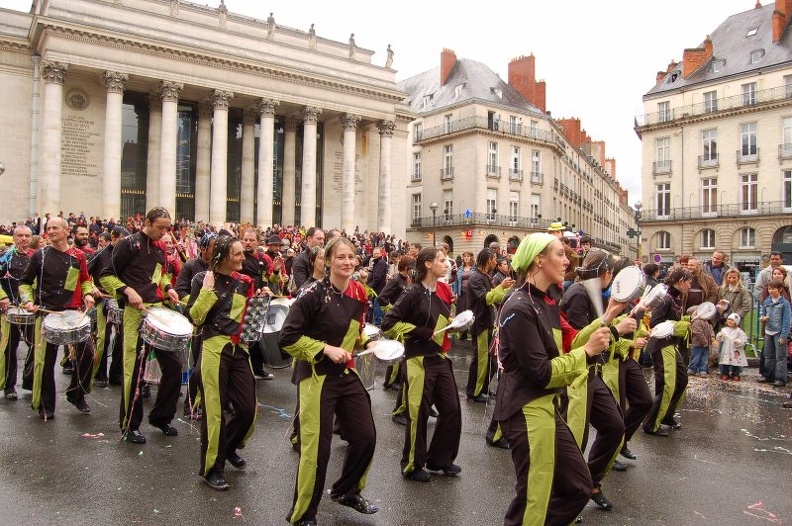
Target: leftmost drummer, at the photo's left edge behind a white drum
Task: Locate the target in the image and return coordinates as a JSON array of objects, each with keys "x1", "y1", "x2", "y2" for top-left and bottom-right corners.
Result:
[{"x1": 0, "y1": 225, "x2": 35, "y2": 400}]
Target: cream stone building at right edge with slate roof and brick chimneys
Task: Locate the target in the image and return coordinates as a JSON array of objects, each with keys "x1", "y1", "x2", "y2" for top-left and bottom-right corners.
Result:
[{"x1": 635, "y1": 0, "x2": 792, "y2": 274}]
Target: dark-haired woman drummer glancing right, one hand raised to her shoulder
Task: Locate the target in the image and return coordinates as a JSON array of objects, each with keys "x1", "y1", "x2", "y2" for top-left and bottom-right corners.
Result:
[{"x1": 187, "y1": 236, "x2": 262, "y2": 491}]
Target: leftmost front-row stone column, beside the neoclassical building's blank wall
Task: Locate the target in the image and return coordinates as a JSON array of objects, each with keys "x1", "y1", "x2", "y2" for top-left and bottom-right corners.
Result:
[{"x1": 38, "y1": 61, "x2": 69, "y2": 217}]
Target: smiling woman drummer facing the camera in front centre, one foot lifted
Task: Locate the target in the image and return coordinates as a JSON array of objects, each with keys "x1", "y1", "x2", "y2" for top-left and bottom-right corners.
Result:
[{"x1": 280, "y1": 237, "x2": 378, "y2": 526}]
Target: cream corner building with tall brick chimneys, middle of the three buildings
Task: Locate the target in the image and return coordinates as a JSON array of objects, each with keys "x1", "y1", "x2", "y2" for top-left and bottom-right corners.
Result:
[{"x1": 399, "y1": 49, "x2": 635, "y2": 254}]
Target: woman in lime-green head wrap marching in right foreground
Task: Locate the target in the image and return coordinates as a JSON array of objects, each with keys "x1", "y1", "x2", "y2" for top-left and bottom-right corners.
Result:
[{"x1": 495, "y1": 233, "x2": 611, "y2": 525}]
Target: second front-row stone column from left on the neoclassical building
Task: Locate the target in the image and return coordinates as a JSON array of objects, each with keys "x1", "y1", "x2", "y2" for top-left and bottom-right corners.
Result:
[{"x1": 102, "y1": 71, "x2": 129, "y2": 218}]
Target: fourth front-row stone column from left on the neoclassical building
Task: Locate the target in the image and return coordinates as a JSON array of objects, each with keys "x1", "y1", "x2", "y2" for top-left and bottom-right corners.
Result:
[{"x1": 209, "y1": 90, "x2": 234, "y2": 227}]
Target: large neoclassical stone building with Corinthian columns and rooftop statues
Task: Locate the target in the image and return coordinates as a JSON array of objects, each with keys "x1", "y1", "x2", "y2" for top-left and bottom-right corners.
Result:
[{"x1": 0, "y1": 0, "x2": 411, "y2": 237}]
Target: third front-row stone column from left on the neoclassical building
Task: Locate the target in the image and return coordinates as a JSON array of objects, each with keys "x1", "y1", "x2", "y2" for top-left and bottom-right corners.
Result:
[{"x1": 158, "y1": 80, "x2": 184, "y2": 214}]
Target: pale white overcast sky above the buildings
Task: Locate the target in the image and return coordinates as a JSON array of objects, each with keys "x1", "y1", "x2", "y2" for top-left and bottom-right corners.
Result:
[{"x1": 0, "y1": 0, "x2": 769, "y2": 208}]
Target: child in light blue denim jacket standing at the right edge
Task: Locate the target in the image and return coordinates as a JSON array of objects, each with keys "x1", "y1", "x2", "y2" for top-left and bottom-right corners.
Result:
[{"x1": 759, "y1": 279, "x2": 792, "y2": 387}]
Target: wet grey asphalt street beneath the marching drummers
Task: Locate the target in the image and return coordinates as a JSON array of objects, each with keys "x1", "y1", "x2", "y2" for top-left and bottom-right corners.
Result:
[{"x1": 0, "y1": 341, "x2": 792, "y2": 526}]
